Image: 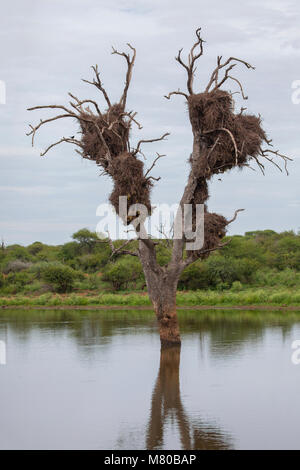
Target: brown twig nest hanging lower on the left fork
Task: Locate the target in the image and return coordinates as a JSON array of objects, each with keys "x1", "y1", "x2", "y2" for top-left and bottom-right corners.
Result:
[{"x1": 109, "y1": 152, "x2": 152, "y2": 225}]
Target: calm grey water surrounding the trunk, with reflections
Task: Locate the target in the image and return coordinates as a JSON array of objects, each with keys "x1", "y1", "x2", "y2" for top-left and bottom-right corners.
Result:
[{"x1": 0, "y1": 309, "x2": 300, "y2": 450}]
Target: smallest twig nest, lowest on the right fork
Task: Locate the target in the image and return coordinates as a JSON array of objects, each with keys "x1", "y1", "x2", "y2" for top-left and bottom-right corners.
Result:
[{"x1": 196, "y1": 212, "x2": 227, "y2": 259}]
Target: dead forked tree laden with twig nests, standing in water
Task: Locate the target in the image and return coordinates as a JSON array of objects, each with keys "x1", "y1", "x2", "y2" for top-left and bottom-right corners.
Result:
[{"x1": 27, "y1": 29, "x2": 289, "y2": 345}]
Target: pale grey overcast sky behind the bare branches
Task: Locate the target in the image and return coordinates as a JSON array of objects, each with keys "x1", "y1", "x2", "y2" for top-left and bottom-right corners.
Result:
[{"x1": 0, "y1": 0, "x2": 300, "y2": 245}]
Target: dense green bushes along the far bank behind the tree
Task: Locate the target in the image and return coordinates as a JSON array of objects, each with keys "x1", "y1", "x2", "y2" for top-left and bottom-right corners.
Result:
[{"x1": 0, "y1": 229, "x2": 300, "y2": 304}]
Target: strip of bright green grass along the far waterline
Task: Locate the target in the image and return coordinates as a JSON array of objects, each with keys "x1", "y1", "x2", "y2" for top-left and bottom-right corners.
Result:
[{"x1": 0, "y1": 288, "x2": 300, "y2": 307}]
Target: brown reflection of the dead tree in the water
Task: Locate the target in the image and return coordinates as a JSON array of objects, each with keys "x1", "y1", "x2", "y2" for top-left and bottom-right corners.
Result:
[{"x1": 146, "y1": 347, "x2": 231, "y2": 450}]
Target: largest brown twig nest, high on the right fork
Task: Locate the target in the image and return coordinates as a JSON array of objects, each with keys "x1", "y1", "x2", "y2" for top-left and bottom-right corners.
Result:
[{"x1": 188, "y1": 90, "x2": 267, "y2": 178}]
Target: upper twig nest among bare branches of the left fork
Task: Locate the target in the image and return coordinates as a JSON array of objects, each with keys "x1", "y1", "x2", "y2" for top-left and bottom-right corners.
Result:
[{"x1": 81, "y1": 104, "x2": 130, "y2": 165}]
